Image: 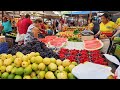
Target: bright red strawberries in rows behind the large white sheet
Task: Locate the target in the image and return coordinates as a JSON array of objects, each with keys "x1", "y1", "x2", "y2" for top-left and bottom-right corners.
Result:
[{"x1": 58, "y1": 49, "x2": 108, "y2": 65}]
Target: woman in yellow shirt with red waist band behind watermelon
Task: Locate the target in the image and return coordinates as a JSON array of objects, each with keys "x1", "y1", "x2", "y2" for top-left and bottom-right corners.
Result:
[{"x1": 95, "y1": 13, "x2": 117, "y2": 53}]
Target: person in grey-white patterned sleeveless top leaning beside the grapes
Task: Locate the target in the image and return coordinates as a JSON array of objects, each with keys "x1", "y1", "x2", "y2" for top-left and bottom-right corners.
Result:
[{"x1": 24, "y1": 19, "x2": 42, "y2": 44}]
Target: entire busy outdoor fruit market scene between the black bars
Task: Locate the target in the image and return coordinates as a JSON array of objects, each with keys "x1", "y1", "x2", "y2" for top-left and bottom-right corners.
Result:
[{"x1": 0, "y1": 11, "x2": 120, "y2": 79}]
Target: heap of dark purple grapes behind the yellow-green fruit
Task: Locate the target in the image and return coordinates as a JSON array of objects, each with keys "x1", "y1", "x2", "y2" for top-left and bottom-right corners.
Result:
[{"x1": 7, "y1": 40, "x2": 59, "y2": 59}]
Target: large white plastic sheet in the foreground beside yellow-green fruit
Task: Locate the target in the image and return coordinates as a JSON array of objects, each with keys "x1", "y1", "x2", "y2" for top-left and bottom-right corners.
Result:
[{"x1": 72, "y1": 62, "x2": 114, "y2": 79}]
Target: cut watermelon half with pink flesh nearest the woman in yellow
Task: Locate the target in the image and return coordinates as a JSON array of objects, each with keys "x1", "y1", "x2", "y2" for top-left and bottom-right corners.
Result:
[{"x1": 83, "y1": 39, "x2": 103, "y2": 51}]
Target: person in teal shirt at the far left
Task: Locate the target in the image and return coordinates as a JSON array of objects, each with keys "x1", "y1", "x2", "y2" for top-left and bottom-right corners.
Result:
[{"x1": 2, "y1": 16, "x2": 12, "y2": 34}]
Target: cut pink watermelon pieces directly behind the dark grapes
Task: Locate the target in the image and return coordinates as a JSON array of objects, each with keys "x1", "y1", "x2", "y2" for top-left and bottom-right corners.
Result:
[{"x1": 39, "y1": 36, "x2": 67, "y2": 48}]
